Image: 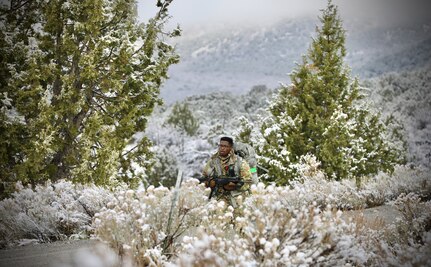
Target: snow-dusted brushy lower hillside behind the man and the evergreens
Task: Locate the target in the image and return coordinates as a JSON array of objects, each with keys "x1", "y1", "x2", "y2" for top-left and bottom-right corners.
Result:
[{"x1": 146, "y1": 68, "x2": 431, "y2": 183}]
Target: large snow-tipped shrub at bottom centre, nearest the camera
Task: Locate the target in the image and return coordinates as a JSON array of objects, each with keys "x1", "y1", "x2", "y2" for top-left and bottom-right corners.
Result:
[{"x1": 176, "y1": 184, "x2": 367, "y2": 266}]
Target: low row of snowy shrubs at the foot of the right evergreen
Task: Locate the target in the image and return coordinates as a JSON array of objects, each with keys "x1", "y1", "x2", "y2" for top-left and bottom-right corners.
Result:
[{"x1": 286, "y1": 165, "x2": 431, "y2": 209}]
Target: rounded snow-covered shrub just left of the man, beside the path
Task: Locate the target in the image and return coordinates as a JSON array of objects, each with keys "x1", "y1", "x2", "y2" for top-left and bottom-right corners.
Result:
[{"x1": 93, "y1": 179, "x2": 211, "y2": 266}]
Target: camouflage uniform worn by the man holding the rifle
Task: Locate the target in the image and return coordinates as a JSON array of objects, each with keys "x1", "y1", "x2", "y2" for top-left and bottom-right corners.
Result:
[{"x1": 202, "y1": 149, "x2": 252, "y2": 208}]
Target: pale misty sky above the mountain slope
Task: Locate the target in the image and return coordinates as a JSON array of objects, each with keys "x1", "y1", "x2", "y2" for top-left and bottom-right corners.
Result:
[{"x1": 138, "y1": 0, "x2": 431, "y2": 31}]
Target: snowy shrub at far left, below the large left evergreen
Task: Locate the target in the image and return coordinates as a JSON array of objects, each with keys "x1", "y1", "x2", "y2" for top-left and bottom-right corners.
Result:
[{"x1": 0, "y1": 181, "x2": 112, "y2": 246}]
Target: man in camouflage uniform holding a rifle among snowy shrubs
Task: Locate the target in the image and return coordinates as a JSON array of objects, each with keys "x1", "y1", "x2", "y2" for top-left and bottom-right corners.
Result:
[{"x1": 203, "y1": 136, "x2": 252, "y2": 208}]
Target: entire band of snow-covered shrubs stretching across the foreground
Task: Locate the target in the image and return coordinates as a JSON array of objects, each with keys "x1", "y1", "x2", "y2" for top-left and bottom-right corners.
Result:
[{"x1": 0, "y1": 168, "x2": 431, "y2": 266}]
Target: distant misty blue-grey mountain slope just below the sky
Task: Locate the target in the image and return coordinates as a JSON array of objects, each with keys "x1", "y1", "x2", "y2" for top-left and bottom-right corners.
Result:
[{"x1": 161, "y1": 18, "x2": 431, "y2": 103}]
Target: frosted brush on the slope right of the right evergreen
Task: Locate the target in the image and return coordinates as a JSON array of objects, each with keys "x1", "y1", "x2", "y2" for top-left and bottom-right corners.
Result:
[{"x1": 364, "y1": 67, "x2": 431, "y2": 167}]
